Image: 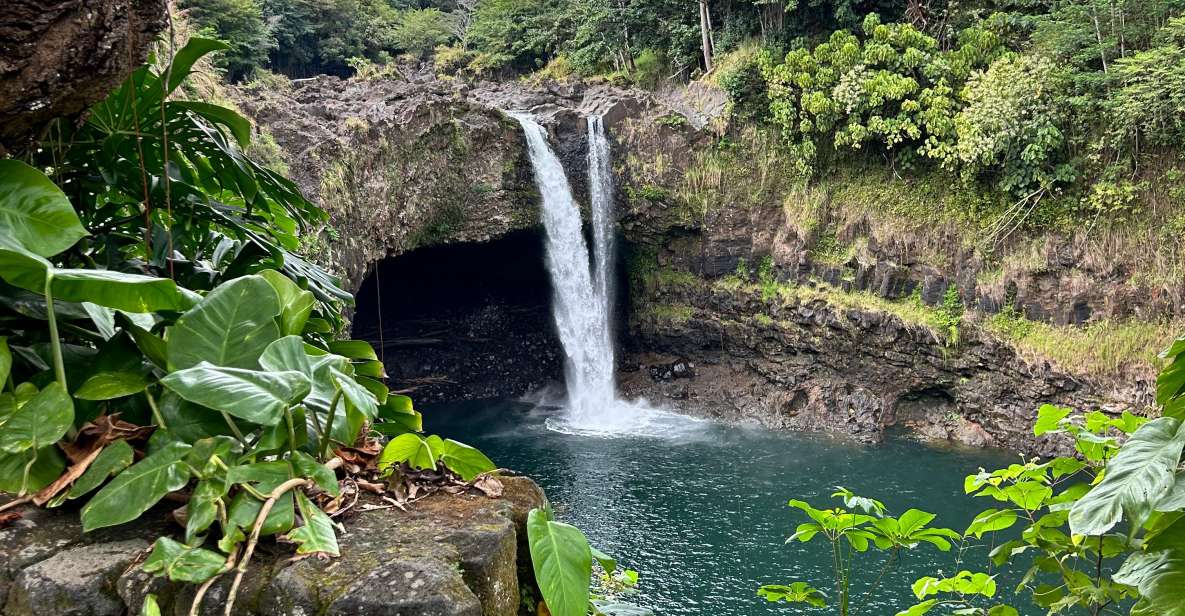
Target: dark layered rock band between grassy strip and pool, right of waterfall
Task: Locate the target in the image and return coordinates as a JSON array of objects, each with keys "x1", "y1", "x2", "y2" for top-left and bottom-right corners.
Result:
[{"x1": 620, "y1": 283, "x2": 1147, "y2": 454}]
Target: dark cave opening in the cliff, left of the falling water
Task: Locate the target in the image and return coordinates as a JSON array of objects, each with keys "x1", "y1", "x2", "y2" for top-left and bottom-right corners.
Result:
[{"x1": 353, "y1": 231, "x2": 563, "y2": 404}]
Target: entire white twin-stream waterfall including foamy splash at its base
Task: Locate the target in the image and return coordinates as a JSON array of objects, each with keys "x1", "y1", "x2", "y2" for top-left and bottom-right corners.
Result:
[{"x1": 510, "y1": 114, "x2": 687, "y2": 435}]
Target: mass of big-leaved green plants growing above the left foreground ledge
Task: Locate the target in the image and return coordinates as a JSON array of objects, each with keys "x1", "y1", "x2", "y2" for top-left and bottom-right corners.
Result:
[{"x1": 0, "y1": 39, "x2": 494, "y2": 612}]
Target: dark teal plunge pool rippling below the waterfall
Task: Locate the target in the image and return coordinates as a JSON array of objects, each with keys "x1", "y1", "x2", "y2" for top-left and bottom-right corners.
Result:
[{"x1": 424, "y1": 402, "x2": 1036, "y2": 616}]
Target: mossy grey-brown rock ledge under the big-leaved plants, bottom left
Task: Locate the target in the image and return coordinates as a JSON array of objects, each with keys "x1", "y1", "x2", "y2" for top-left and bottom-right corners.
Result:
[{"x1": 0, "y1": 477, "x2": 545, "y2": 616}]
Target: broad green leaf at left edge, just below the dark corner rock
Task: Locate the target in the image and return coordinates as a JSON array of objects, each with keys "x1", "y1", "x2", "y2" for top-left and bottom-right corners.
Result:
[{"x1": 0, "y1": 159, "x2": 88, "y2": 257}]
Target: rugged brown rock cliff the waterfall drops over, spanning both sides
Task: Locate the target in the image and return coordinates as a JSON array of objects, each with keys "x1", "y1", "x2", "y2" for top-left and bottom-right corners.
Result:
[{"x1": 235, "y1": 73, "x2": 1161, "y2": 450}]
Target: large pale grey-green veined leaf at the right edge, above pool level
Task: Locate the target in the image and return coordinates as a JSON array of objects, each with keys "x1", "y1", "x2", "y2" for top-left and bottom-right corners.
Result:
[{"x1": 1069, "y1": 417, "x2": 1185, "y2": 535}]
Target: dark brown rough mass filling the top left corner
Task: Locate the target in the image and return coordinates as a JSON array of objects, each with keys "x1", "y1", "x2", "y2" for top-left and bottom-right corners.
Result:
[{"x1": 0, "y1": 0, "x2": 166, "y2": 154}]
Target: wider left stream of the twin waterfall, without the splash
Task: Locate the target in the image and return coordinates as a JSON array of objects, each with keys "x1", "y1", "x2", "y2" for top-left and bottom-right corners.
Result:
[{"x1": 511, "y1": 114, "x2": 616, "y2": 425}]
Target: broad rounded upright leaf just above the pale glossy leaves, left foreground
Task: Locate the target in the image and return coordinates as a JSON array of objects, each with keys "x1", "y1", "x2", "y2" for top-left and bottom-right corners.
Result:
[{"x1": 166, "y1": 276, "x2": 280, "y2": 370}]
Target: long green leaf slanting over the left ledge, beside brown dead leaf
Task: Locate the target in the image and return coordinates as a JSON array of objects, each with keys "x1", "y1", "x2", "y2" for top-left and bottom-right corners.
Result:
[{"x1": 82, "y1": 442, "x2": 190, "y2": 532}]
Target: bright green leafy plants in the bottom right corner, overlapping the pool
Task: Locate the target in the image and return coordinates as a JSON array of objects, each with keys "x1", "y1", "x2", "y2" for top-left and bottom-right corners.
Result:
[{"x1": 758, "y1": 338, "x2": 1185, "y2": 616}]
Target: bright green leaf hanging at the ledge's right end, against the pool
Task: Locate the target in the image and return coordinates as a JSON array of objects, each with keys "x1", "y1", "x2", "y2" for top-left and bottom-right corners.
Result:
[{"x1": 526, "y1": 509, "x2": 593, "y2": 616}]
